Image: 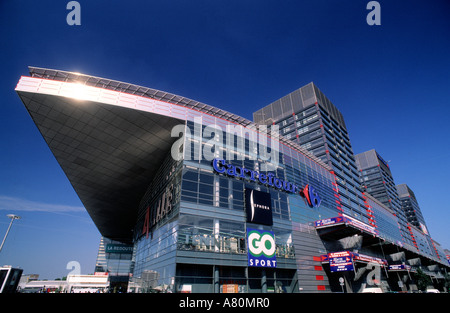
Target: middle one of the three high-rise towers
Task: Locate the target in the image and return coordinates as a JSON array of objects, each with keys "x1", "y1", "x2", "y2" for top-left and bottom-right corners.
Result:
[{"x1": 355, "y1": 149, "x2": 413, "y2": 244}]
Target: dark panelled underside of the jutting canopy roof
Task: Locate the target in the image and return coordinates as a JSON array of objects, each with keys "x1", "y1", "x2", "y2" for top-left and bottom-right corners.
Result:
[{"x1": 17, "y1": 75, "x2": 183, "y2": 242}]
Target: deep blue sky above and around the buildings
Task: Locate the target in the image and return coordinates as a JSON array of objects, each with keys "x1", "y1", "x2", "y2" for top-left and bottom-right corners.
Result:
[{"x1": 0, "y1": 0, "x2": 450, "y2": 279}]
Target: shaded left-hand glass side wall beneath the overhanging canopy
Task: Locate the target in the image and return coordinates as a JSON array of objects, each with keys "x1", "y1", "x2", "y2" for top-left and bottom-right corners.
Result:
[{"x1": 132, "y1": 151, "x2": 182, "y2": 292}]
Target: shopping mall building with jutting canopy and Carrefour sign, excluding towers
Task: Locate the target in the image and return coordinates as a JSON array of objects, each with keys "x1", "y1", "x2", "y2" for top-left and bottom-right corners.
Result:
[{"x1": 16, "y1": 67, "x2": 449, "y2": 293}]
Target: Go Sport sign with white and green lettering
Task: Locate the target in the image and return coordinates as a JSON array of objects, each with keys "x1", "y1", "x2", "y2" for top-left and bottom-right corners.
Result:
[{"x1": 247, "y1": 228, "x2": 277, "y2": 268}]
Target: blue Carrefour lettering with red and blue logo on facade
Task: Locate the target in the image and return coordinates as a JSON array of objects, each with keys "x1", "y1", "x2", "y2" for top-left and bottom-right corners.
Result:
[{"x1": 212, "y1": 159, "x2": 321, "y2": 207}]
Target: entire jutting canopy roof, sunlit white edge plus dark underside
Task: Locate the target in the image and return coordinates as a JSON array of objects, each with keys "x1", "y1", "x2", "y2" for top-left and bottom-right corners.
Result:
[{"x1": 16, "y1": 67, "x2": 330, "y2": 242}]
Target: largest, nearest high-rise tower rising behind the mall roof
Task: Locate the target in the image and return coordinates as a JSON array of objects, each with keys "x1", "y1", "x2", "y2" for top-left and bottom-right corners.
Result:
[{"x1": 253, "y1": 82, "x2": 371, "y2": 223}]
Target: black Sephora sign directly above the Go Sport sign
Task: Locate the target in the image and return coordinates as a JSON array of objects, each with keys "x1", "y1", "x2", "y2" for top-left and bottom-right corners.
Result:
[{"x1": 245, "y1": 189, "x2": 273, "y2": 225}]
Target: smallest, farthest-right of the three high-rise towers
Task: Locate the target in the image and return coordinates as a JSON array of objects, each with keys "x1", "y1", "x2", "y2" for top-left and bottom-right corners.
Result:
[{"x1": 396, "y1": 184, "x2": 428, "y2": 234}]
